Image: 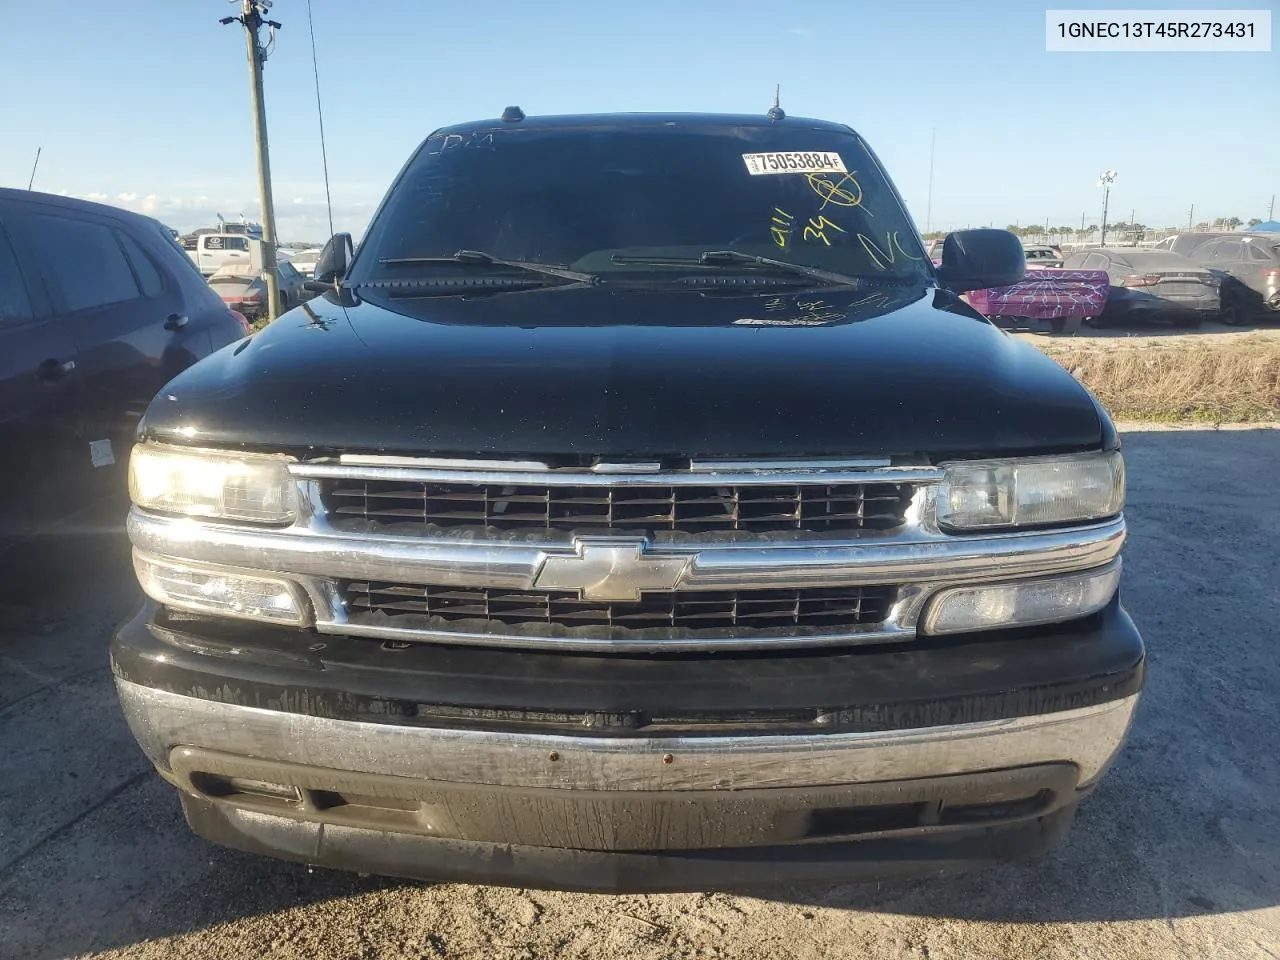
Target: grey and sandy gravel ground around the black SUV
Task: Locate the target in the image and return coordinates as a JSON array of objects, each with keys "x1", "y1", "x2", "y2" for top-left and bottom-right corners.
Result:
[{"x1": 0, "y1": 430, "x2": 1280, "y2": 960}]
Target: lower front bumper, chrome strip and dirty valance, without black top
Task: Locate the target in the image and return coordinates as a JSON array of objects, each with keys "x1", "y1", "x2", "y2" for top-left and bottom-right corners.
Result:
[{"x1": 118, "y1": 681, "x2": 1137, "y2": 890}]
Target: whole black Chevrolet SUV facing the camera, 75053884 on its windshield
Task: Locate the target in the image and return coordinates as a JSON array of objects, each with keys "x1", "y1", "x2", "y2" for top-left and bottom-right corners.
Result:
[{"x1": 111, "y1": 110, "x2": 1143, "y2": 890}]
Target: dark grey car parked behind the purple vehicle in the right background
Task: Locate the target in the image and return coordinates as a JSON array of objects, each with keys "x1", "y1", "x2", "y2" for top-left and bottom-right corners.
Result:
[{"x1": 1064, "y1": 247, "x2": 1219, "y2": 326}]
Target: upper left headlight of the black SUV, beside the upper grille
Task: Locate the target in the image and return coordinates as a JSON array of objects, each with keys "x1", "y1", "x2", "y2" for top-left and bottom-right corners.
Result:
[{"x1": 129, "y1": 443, "x2": 297, "y2": 524}]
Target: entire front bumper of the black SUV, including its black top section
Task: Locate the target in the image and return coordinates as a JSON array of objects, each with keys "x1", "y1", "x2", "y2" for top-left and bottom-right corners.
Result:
[{"x1": 111, "y1": 602, "x2": 1143, "y2": 891}]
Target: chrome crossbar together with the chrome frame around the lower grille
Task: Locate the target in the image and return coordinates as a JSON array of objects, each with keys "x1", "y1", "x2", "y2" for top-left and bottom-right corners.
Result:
[{"x1": 128, "y1": 508, "x2": 1125, "y2": 652}]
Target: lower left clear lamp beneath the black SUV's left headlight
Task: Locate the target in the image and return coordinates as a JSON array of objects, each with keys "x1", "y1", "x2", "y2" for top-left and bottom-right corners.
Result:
[{"x1": 133, "y1": 550, "x2": 310, "y2": 626}]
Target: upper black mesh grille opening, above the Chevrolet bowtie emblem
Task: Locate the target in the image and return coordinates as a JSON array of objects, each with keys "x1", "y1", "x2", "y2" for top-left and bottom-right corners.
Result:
[{"x1": 320, "y1": 479, "x2": 913, "y2": 534}]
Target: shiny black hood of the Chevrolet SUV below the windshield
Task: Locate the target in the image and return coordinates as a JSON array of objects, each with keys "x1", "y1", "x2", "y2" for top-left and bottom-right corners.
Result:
[{"x1": 142, "y1": 284, "x2": 1110, "y2": 462}]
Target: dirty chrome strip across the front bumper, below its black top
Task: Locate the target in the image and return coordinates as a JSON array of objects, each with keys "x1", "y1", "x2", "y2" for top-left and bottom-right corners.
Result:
[{"x1": 116, "y1": 678, "x2": 1138, "y2": 791}]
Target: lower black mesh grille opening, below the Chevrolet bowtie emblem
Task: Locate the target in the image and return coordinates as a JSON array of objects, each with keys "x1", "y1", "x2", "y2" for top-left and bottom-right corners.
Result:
[{"x1": 340, "y1": 581, "x2": 897, "y2": 631}]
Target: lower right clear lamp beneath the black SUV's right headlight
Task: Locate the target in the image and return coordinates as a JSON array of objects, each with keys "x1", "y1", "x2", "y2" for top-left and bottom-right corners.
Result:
[{"x1": 920, "y1": 561, "x2": 1120, "y2": 634}]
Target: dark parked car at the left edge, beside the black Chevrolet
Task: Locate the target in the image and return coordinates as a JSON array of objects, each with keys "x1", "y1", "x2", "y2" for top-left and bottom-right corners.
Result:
[{"x1": 0, "y1": 189, "x2": 247, "y2": 545}]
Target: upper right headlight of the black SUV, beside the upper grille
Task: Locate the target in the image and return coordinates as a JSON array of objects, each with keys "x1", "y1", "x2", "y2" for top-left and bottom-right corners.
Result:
[{"x1": 936, "y1": 452, "x2": 1124, "y2": 530}]
